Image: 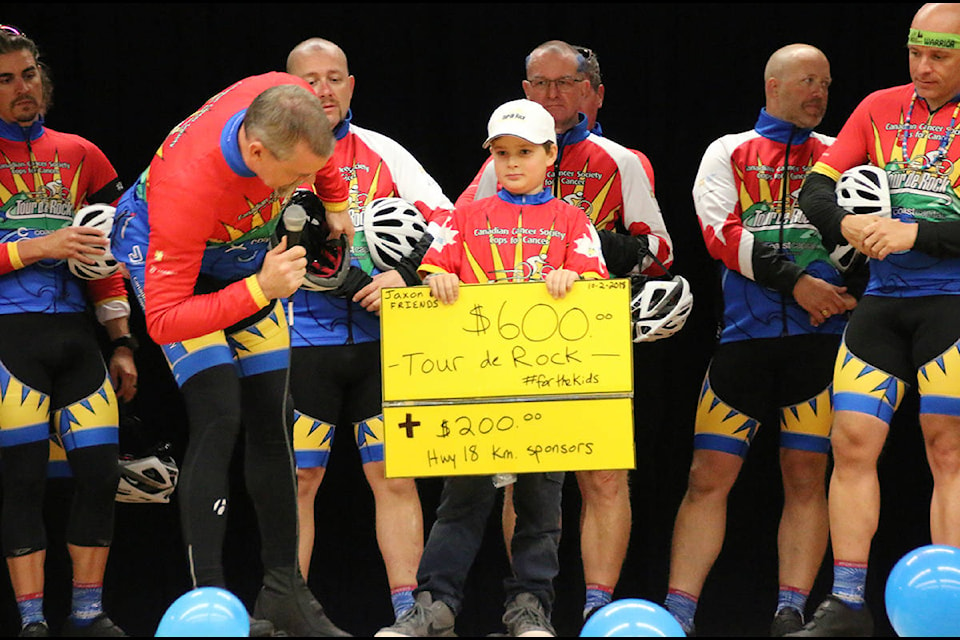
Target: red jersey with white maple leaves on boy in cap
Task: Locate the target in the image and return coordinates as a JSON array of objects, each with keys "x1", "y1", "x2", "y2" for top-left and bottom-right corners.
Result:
[{"x1": 420, "y1": 189, "x2": 609, "y2": 283}]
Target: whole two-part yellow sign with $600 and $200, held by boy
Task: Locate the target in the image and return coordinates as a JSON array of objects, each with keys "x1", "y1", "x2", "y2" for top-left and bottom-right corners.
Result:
[{"x1": 380, "y1": 280, "x2": 636, "y2": 478}]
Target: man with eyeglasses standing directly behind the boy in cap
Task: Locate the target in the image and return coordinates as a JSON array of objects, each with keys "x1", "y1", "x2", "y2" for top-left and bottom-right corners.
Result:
[{"x1": 457, "y1": 40, "x2": 673, "y2": 618}]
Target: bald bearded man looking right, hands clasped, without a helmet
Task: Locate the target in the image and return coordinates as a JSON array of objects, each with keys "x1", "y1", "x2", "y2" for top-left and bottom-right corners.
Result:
[{"x1": 665, "y1": 44, "x2": 856, "y2": 637}]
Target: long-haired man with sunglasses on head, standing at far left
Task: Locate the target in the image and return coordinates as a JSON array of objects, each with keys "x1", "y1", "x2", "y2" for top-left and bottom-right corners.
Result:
[{"x1": 0, "y1": 26, "x2": 137, "y2": 637}]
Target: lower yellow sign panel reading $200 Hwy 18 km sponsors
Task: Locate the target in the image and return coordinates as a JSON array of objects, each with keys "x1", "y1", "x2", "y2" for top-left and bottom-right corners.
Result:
[{"x1": 383, "y1": 398, "x2": 636, "y2": 478}]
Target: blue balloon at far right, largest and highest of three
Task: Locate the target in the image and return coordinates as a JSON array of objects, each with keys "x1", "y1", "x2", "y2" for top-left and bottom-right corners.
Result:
[{"x1": 884, "y1": 544, "x2": 960, "y2": 637}]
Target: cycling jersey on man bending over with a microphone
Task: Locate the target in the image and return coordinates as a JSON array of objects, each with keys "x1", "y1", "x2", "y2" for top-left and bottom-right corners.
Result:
[{"x1": 113, "y1": 72, "x2": 347, "y2": 344}]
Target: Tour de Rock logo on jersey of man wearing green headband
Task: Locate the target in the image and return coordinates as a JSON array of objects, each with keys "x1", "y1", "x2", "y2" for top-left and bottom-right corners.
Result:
[{"x1": 872, "y1": 114, "x2": 960, "y2": 220}]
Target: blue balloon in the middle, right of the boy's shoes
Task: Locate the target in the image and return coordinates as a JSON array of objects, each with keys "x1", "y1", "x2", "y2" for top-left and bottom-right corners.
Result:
[{"x1": 580, "y1": 598, "x2": 687, "y2": 638}]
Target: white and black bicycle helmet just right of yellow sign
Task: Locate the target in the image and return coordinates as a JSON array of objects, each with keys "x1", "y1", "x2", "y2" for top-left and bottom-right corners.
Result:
[{"x1": 630, "y1": 276, "x2": 693, "y2": 342}]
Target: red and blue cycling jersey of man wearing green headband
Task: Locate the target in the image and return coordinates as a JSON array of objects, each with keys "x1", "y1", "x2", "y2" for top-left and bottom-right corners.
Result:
[{"x1": 813, "y1": 84, "x2": 960, "y2": 298}]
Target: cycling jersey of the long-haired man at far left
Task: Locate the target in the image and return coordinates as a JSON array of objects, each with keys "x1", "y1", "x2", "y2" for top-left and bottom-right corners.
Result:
[{"x1": 0, "y1": 119, "x2": 129, "y2": 321}]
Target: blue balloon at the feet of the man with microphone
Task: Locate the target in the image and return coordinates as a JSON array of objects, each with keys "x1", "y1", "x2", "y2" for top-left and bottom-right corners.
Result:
[{"x1": 156, "y1": 587, "x2": 250, "y2": 638}]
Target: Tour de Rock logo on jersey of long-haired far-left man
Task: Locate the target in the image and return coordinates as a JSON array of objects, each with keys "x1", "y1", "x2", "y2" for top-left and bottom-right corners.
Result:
[{"x1": 0, "y1": 153, "x2": 86, "y2": 231}]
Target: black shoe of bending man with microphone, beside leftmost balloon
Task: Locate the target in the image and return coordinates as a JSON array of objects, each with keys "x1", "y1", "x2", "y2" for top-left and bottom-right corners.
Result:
[{"x1": 253, "y1": 573, "x2": 350, "y2": 638}]
